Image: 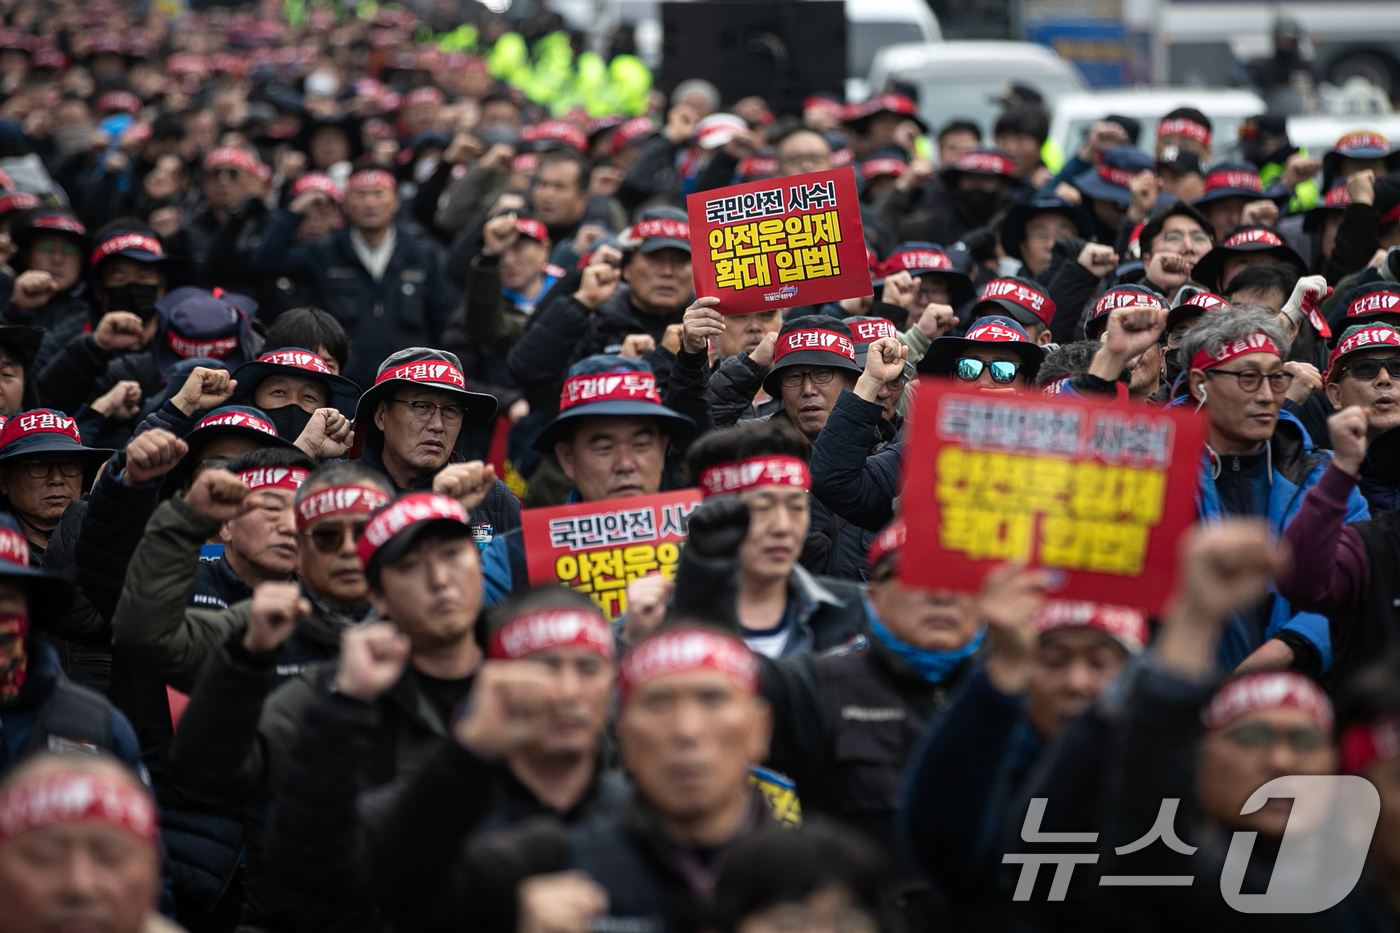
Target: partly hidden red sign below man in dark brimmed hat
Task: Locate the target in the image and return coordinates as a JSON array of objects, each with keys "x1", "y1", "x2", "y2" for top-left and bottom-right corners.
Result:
[{"x1": 521, "y1": 489, "x2": 700, "y2": 621}]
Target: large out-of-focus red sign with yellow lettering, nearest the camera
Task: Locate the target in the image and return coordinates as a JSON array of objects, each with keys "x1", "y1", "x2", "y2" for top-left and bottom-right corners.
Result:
[{"x1": 900, "y1": 380, "x2": 1203, "y2": 614}]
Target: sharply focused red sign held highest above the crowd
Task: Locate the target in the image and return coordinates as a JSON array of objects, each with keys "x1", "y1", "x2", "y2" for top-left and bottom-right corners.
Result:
[{"x1": 686, "y1": 167, "x2": 871, "y2": 314}]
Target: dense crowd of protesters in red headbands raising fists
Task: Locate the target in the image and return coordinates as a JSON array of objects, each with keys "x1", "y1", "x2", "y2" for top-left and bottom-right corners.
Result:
[{"x1": 0, "y1": 0, "x2": 1400, "y2": 933}]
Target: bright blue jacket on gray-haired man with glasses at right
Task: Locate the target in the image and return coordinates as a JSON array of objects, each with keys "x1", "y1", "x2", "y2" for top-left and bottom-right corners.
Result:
[{"x1": 1196, "y1": 410, "x2": 1371, "y2": 674}]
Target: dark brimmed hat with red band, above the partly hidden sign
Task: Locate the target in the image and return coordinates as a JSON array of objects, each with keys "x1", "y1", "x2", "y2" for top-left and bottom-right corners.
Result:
[{"x1": 535, "y1": 353, "x2": 694, "y2": 452}]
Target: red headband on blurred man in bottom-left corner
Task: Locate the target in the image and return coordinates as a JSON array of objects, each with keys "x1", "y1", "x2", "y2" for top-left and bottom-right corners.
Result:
[{"x1": 0, "y1": 772, "x2": 157, "y2": 845}]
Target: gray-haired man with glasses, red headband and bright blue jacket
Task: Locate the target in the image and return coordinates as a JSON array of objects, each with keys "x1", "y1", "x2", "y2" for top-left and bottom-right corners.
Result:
[{"x1": 1177, "y1": 308, "x2": 1369, "y2": 677}]
